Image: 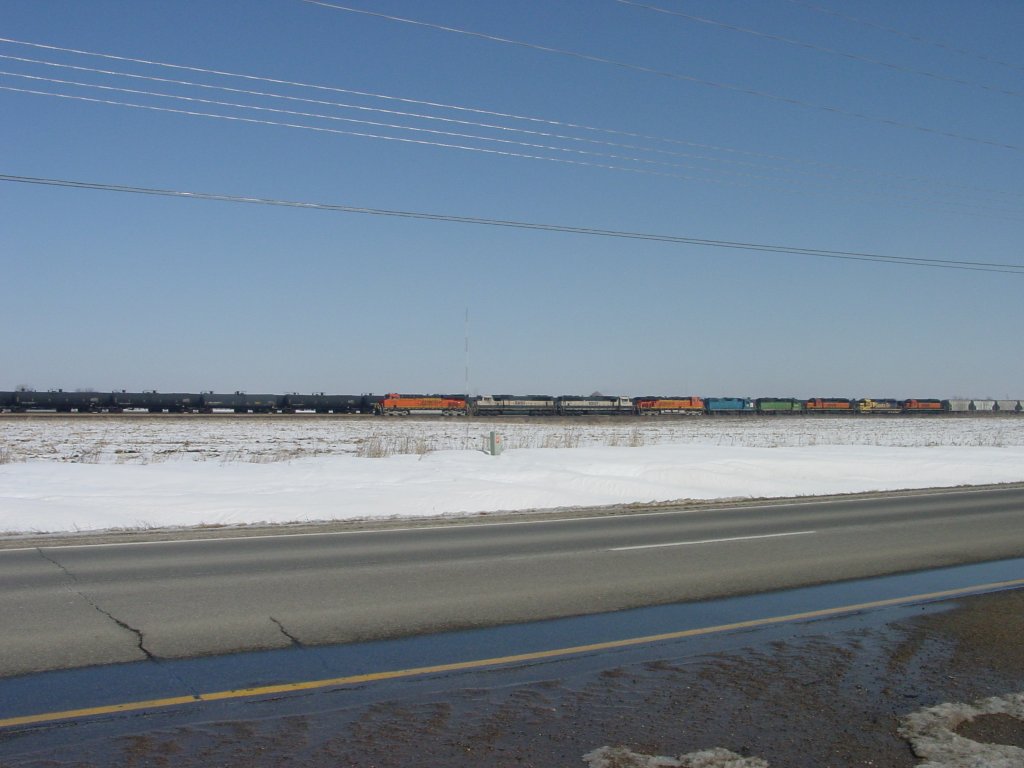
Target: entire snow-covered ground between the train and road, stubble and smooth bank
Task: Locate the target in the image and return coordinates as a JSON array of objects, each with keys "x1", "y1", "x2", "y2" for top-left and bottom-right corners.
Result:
[{"x1": 0, "y1": 415, "x2": 1024, "y2": 532}]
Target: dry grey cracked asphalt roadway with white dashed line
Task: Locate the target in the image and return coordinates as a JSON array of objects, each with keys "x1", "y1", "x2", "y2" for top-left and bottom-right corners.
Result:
[{"x1": 0, "y1": 486, "x2": 1024, "y2": 677}]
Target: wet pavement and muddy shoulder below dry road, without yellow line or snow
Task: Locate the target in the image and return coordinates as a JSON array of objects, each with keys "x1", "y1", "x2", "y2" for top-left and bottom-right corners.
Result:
[{"x1": 0, "y1": 560, "x2": 1024, "y2": 768}]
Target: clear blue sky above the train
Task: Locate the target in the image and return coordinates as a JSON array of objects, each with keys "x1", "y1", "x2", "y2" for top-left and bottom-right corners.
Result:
[{"x1": 0, "y1": 0, "x2": 1024, "y2": 397}]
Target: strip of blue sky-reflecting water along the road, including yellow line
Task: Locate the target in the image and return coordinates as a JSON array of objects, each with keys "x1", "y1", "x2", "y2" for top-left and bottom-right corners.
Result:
[{"x1": 0, "y1": 559, "x2": 1024, "y2": 764}]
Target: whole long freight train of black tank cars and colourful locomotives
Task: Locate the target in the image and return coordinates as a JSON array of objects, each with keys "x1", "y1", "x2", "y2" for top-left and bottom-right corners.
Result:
[{"x1": 0, "y1": 389, "x2": 1024, "y2": 416}]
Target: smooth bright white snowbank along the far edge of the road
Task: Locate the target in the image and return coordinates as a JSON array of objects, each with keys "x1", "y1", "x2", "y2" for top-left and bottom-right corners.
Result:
[{"x1": 0, "y1": 444, "x2": 1024, "y2": 532}]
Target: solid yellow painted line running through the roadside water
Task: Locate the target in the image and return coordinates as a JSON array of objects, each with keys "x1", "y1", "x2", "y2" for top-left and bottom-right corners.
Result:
[{"x1": 0, "y1": 579, "x2": 1024, "y2": 728}]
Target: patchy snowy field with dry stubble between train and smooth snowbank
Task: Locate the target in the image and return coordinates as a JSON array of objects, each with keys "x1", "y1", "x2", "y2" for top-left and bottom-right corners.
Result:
[{"x1": 0, "y1": 415, "x2": 1024, "y2": 465}]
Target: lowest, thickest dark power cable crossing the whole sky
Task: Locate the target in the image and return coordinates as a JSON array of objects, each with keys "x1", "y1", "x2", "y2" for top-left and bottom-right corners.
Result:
[{"x1": 0, "y1": 173, "x2": 1024, "y2": 275}]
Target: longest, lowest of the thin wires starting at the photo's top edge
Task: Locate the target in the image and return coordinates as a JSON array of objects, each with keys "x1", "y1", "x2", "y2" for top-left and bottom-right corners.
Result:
[{"x1": 302, "y1": 0, "x2": 1024, "y2": 152}]
